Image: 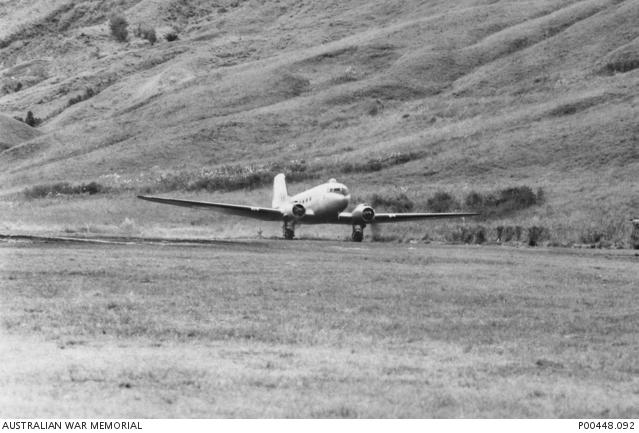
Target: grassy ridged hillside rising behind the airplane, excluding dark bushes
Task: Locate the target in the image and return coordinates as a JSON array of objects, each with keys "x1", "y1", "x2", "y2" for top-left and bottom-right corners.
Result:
[{"x1": 0, "y1": 0, "x2": 639, "y2": 242}]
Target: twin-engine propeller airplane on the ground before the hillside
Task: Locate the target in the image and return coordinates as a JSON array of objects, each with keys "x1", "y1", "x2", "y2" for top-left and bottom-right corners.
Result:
[{"x1": 137, "y1": 173, "x2": 479, "y2": 242}]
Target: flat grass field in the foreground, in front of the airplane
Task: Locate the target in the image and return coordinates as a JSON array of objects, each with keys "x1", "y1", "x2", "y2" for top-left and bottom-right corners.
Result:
[{"x1": 0, "y1": 241, "x2": 639, "y2": 418}]
